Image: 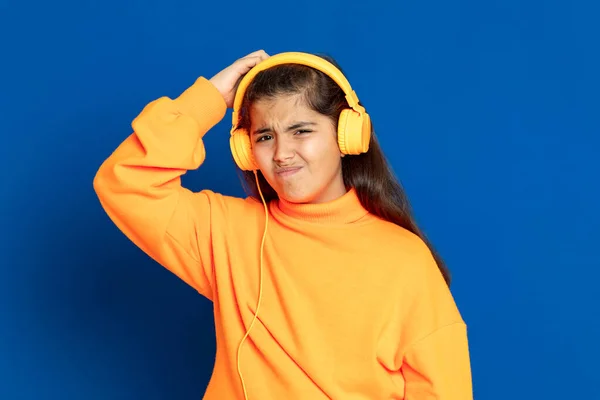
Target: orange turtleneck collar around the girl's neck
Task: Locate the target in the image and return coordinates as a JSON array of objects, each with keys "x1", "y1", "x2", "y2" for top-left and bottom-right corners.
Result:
[{"x1": 275, "y1": 188, "x2": 368, "y2": 224}]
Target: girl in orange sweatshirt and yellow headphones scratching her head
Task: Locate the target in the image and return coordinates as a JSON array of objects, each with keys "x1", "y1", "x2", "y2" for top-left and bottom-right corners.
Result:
[{"x1": 94, "y1": 51, "x2": 472, "y2": 400}]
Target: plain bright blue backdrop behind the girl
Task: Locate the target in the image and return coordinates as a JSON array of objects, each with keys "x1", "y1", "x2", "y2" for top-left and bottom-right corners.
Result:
[{"x1": 0, "y1": 0, "x2": 600, "y2": 400}]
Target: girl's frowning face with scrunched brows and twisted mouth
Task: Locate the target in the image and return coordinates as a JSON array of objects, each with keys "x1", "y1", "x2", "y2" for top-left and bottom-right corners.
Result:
[{"x1": 250, "y1": 95, "x2": 346, "y2": 203}]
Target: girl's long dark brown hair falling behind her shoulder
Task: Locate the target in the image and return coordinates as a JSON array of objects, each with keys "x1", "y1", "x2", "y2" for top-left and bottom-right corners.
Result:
[{"x1": 239, "y1": 55, "x2": 451, "y2": 286}]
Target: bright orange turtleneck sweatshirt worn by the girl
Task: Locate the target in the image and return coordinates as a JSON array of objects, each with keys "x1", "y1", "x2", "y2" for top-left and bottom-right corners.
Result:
[{"x1": 94, "y1": 77, "x2": 472, "y2": 400}]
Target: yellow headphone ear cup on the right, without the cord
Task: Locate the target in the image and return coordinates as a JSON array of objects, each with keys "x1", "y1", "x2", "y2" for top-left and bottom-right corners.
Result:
[{"x1": 338, "y1": 108, "x2": 371, "y2": 155}]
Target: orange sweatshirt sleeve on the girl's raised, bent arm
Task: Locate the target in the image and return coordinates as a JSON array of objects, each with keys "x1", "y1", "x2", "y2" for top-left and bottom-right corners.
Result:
[{"x1": 93, "y1": 77, "x2": 227, "y2": 299}]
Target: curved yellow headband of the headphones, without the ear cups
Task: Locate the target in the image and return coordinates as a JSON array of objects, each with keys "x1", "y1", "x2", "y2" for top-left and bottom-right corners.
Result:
[{"x1": 231, "y1": 52, "x2": 365, "y2": 134}]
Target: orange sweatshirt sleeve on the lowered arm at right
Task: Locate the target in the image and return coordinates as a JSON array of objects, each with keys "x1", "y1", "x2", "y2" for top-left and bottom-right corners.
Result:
[{"x1": 397, "y1": 239, "x2": 473, "y2": 400}]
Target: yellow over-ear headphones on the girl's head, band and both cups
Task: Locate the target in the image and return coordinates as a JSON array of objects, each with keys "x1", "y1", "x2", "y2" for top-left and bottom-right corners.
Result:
[{"x1": 229, "y1": 52, "x2": 371, "y2": 171}]
